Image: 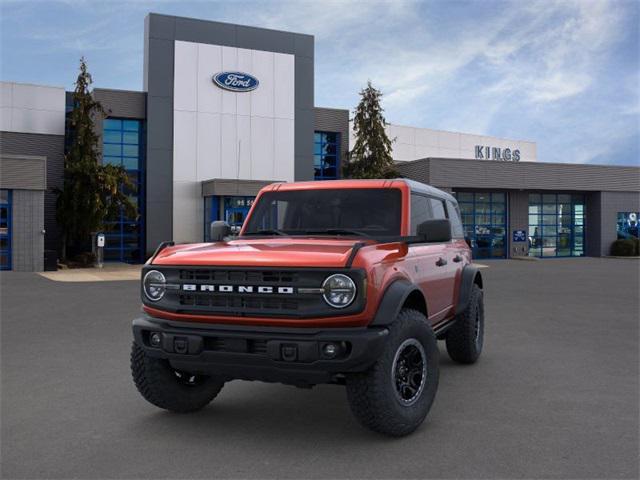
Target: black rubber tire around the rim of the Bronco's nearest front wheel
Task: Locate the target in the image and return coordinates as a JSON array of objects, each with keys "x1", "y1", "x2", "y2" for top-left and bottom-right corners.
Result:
[{"x1": 346, "y1": 309, "x2": 439, "y2": 437}]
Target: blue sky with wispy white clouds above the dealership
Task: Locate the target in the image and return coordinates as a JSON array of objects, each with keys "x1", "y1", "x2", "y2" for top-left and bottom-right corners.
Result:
[{"x1": 0, "y1": 0, "x2": 640, "y2": 165}]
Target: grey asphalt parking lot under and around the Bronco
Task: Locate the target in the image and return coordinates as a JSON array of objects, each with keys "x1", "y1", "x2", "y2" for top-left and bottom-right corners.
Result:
[{"x1": 0, "y1": 258, "x2": 640, "y2": 479}]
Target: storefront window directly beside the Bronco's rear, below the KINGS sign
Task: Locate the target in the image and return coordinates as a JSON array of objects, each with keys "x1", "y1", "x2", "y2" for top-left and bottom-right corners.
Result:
[{"x1": 454, "y1": 192, "x2": 507, "y2": 258}]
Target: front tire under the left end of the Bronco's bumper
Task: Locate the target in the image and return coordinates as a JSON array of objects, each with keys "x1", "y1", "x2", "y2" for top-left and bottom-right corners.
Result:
[{"x1": 131, "y1": 342, "x2": 224, "y2": 413}]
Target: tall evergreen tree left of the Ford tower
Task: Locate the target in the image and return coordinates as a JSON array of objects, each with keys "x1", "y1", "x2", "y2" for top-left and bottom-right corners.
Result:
[{"x1": 55, "y1": 57, "x2": 136, "y2": 261}]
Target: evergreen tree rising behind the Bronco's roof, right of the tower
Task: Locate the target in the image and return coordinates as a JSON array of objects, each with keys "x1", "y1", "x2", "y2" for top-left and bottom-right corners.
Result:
[{"x1": 344, "y1": 81, "x2": 398, "y2": 178}]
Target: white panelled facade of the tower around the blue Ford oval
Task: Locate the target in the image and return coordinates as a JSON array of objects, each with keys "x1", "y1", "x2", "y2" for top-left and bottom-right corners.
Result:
[{"x1": 174, "y1": 41, "x2": 295, "y2": 241}]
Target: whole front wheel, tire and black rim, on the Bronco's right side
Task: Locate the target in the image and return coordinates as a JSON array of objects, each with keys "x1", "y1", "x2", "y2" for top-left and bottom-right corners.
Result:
[{"x1": 346, "y1": 309, "x2": 439, "y2": 437}]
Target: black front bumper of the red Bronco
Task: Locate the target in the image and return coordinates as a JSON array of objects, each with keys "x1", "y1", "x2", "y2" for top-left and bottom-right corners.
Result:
[{"x1": 133, "y1": 316, "x2": 389, "y2": 385}]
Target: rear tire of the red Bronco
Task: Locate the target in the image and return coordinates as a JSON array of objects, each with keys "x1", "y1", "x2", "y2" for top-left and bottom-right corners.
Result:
[{"x1": 446, "y1": 283, "x2": 484, "y2": 363}]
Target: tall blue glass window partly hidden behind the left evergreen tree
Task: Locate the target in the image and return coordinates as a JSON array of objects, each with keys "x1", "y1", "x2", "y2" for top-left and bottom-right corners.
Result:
[{"x1": 102, "y1": 118, "x2": 145, "y2": 263}]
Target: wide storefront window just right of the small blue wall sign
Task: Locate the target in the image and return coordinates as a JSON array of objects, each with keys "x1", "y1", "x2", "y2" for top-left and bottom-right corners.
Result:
[{"x1": 528, "y1": 193, "x2": 585, "y2": 257}]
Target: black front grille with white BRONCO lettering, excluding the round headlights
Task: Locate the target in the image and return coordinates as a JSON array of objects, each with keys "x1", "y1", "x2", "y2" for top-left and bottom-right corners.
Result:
[{"x1": 142, "y1": 265, "x2": 364, "y2": 318}]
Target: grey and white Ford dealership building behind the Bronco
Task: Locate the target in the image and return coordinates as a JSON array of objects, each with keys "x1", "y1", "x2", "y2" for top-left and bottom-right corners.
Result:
[{"x1": 0, "y1": 14, "x2": 640, "y2": 271}]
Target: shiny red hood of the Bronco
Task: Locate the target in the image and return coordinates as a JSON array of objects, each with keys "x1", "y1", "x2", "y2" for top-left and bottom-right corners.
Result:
[{"x1": 153, "y1": 237, "x2": 370, "y2": 267}]
